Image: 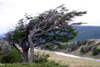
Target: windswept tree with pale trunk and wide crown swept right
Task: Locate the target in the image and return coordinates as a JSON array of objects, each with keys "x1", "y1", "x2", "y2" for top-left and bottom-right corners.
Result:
[{"x1": 5, "y1": 5, "x2": 86, "y2": 62}]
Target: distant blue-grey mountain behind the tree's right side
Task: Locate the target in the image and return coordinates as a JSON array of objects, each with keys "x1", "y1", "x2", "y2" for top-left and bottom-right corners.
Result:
[{"x1": 72, "y1": 26, "x2": 100, "y2": 41}]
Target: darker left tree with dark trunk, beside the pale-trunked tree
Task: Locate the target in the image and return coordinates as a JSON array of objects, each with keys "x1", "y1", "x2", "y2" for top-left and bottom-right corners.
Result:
[{"x1": 6, "y1": 19, "x2": 30, "y2": 63}]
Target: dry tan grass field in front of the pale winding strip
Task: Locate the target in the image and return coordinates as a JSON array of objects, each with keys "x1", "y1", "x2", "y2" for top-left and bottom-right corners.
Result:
[{"x1": 36, "y1": 51, "x2": 100, "y2": 67}]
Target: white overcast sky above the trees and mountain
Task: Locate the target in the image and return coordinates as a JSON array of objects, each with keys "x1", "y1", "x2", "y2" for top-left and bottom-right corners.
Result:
[{"x1": 0, "y1": 0, "x2": 100, "y2": 34}]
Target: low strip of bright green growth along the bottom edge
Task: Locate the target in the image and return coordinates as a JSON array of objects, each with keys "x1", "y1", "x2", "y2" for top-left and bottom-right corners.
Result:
[{"x1": 0, "y1": 61, "x2": 68, "y2": 67}]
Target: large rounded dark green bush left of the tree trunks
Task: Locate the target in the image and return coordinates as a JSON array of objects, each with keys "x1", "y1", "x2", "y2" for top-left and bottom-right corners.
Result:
[{"x1": 0, "y1": 45, "x2": 23, "y2": 63}]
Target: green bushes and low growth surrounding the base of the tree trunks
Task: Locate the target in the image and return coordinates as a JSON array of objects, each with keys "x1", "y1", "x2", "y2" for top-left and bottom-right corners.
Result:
[{"x1": 0, "y1": 45, "x2": 68, "y2": 67}]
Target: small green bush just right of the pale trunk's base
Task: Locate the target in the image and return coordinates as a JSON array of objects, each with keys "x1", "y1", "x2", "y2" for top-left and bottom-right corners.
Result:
[{"x1": 34, "y1": 52, "x2": 50, "y2": 63}]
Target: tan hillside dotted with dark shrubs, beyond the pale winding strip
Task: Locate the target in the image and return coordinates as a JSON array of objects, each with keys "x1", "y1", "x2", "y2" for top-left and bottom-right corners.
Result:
[{"x1": 60, "y1": 39, "x2": 100, "y2": 59}]
